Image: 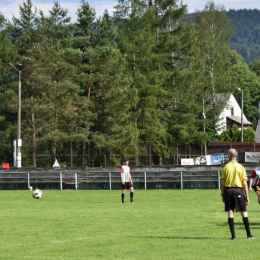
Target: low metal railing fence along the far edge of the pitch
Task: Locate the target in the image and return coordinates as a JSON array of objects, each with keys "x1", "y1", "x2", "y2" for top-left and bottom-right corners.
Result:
[{"x1": 0, "y1": 171, "x2": 220, "y2": 190}]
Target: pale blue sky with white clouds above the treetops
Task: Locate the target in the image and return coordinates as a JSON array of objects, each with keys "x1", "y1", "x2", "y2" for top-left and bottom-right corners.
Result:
[{"x1": 0, "y1": 0, "x2": 260, "y2": 22}]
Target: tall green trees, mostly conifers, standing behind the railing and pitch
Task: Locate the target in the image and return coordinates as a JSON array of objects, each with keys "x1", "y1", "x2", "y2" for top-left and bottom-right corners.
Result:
[{"x1": 0, "y1": 0, "x2": 260, "y2": 167}]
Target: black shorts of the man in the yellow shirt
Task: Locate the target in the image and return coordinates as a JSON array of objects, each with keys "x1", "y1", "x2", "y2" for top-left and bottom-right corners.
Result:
[{"x1": 224, "y1": 188, "x2": 246, "y2": 212}]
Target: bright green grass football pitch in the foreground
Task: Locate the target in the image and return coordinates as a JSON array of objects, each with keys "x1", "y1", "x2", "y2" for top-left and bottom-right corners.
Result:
[{"x1": 0, "y1": 190, "x2": 260, "y2": 260}]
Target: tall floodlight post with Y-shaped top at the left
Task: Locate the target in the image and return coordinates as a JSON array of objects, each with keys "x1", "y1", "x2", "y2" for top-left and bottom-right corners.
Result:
[{"x1": 8, "y1": 62, "x2": 31, "y2": 168}]
